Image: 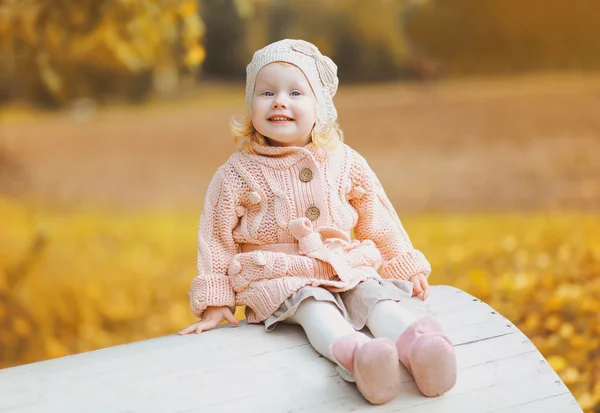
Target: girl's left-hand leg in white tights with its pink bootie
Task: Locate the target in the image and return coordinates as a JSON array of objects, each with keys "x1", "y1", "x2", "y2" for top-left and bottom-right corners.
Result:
[{"x1": 287, "y1": 298, "x2": 401, "y2": 404}]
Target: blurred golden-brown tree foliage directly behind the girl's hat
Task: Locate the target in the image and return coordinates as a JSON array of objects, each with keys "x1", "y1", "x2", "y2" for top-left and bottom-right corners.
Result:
[{"x1": 241, "y1": 0, "x2": 427, "y2": 81}]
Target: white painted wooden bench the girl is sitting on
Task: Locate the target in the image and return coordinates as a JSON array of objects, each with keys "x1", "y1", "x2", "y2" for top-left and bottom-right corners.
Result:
[{"x1": 0, "y1": 286, "x2": 582, "y2": 413}]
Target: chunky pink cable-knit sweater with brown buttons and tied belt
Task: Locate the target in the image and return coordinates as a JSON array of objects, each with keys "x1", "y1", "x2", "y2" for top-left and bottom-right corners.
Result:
[{"x1": 190, "y1": 143, "x2": 431, "y2": 323}]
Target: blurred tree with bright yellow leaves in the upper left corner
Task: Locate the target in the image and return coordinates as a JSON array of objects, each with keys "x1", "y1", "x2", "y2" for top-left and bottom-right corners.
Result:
[{"x1": 0, "y1": 0, "x2": 205, "y2": 105}]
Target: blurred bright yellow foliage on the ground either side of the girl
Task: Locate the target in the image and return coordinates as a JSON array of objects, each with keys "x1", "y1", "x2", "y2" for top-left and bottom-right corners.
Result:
[{"x1": 0, "y1": 198, "x2": 600, "y2": 410}]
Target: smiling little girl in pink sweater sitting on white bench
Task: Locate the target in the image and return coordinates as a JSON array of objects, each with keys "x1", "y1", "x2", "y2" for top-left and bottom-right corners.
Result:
[{"x1": 179, "y1": 40, "x2": 456, "y2": 404}]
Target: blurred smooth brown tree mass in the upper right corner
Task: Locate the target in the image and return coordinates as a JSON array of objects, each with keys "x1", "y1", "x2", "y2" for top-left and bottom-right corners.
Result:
[{"x1": 407, "y1": 0, "x2": 600, "y2": 75}]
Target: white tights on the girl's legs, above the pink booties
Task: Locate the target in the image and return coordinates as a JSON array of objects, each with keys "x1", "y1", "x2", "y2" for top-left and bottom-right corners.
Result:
[{"x1": 286, "y1": 298, "x2": 416, "y2": 361}]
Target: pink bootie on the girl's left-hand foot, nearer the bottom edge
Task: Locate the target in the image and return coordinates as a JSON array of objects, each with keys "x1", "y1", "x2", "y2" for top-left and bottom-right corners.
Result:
[{"x1": 331, "y1": 334, "x2": 401, "y2": 404}]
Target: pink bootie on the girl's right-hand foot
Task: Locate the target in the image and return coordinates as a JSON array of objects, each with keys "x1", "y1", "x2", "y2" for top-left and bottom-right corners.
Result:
[{"x1": 396, "y1": 317, "x2": 457, "y2": 396}]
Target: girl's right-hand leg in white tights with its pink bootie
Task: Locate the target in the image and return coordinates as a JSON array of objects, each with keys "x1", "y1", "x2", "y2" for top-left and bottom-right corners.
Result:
[{"x1": 367, "y1": 300, "x2": 457, "y2": 396}]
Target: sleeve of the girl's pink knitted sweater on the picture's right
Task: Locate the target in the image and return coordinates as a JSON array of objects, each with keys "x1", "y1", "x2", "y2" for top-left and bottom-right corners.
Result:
[{"x1": 350, "y1": 152, "x2": 431, "y2": 280}]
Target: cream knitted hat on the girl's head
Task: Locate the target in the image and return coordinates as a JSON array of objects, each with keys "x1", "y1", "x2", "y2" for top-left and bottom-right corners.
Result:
[{"x1": 246, "y1": 39, "x2": 339, "y2": 123}]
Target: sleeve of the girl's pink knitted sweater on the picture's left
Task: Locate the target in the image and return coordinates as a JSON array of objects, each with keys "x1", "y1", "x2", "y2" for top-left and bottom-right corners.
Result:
[{"x1": 190, "y1": 169, "x2": 238, "y2": 317}]
